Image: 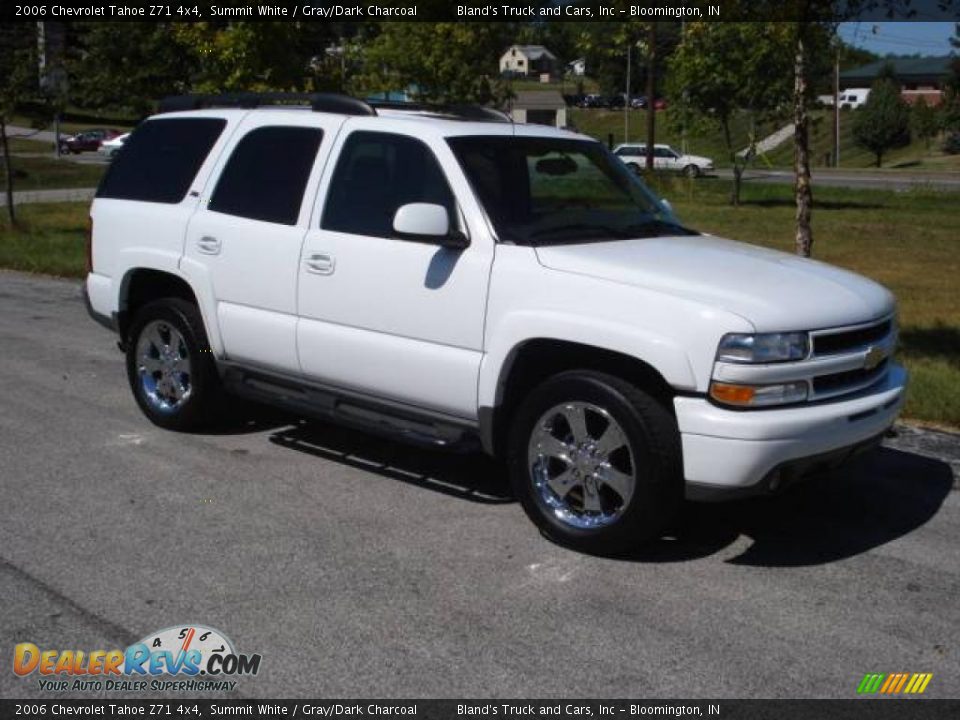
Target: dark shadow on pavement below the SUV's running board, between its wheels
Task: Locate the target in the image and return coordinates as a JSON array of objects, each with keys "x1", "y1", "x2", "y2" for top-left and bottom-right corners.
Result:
[{"x1": 270, "y1": 420, "x2": 515, "y2": 505}]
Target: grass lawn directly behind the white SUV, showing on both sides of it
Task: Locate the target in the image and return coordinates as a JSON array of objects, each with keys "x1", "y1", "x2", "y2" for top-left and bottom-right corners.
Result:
[{"x1": 0, "y1": 186, "x2": 960, "y2": 428}]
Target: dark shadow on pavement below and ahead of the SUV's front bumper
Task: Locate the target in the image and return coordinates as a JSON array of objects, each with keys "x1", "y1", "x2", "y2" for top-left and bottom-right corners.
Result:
[{"x1": 623, "y1": 447, "x2": 955, "y2": 567}]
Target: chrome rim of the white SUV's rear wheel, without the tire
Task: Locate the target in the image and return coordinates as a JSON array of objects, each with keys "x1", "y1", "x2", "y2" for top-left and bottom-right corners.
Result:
[{"x1": 136, "y1": 320, "x2": 193, "y2": 413}]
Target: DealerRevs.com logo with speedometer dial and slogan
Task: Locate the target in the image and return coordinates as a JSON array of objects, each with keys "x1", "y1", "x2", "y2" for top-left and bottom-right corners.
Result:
[{"x1": 13, "y1": 625, "x2": 261, "y2": 692}]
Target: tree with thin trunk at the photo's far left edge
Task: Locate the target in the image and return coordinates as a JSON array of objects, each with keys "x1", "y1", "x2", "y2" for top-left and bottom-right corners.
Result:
[{"x1": 0, "y1": 23, "x2": 39, "y2": 225}]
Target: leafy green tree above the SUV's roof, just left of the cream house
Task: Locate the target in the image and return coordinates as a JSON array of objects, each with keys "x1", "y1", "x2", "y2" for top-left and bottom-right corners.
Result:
[{"x1": 358, "y1": 22, "x2": 517, "y2": 104}]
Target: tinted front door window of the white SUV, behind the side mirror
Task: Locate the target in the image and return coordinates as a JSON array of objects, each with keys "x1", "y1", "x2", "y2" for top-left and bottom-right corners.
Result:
[{"x1": 322, "y1": 132, "x2": 457, "y2": 237}]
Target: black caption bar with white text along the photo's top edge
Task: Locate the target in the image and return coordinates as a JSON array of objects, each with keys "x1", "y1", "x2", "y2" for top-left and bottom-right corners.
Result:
[{"x1": 0, "y1": 0, "x2": 960, "y2": 22}]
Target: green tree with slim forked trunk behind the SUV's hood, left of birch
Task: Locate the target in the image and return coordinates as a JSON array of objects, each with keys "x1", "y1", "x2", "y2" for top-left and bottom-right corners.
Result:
[{"x1": 669, "y1": 22, "x2": 792, "y2": 205}]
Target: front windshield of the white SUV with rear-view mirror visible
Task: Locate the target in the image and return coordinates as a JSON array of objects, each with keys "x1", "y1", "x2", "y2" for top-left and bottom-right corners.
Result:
[{"x1": 448, "y1": 136, "x2": 696, "y2": 245}]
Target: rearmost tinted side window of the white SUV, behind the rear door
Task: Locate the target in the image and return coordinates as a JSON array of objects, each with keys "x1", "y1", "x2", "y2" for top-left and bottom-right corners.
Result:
[{"x1": 97, "y1": 118, "x2": 227, "y2": 204}]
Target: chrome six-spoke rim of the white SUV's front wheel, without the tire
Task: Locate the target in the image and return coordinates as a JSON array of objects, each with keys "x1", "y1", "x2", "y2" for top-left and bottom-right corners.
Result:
[{"x1": 527, "y1": 402, "x2": 636, "y2": 529}]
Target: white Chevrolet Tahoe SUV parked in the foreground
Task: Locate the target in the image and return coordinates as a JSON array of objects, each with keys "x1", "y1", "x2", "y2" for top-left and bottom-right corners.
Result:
[{"x1": 85, "y1": 96, "x2": 906, "y2": 552}]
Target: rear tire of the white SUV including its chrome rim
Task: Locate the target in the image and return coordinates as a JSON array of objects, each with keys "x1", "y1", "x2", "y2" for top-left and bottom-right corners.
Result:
[{"x1": 127, "y1": 298, "x2": 220, "y2": 431}]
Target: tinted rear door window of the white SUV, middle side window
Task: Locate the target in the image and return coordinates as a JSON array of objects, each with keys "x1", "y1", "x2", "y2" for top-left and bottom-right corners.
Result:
[{"x1": 208, "y1": 126, "x2": 323, "y2": 225}]
